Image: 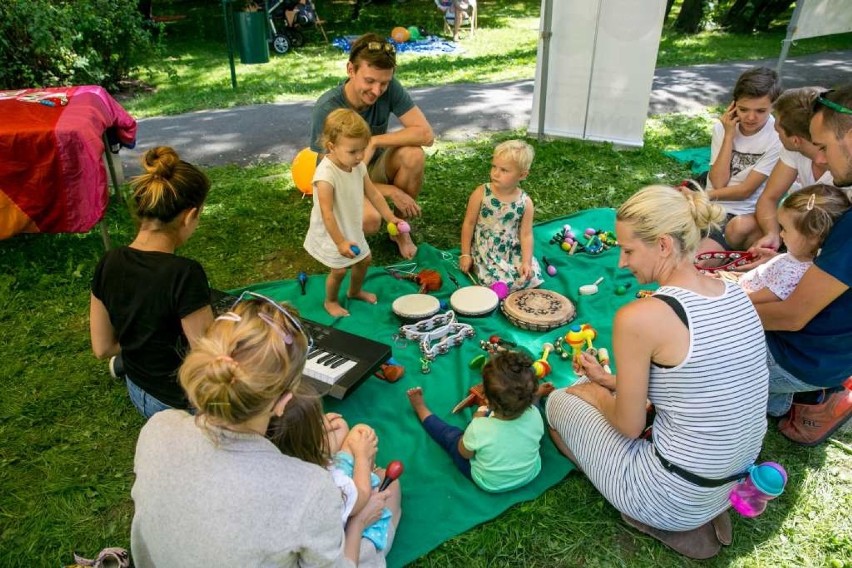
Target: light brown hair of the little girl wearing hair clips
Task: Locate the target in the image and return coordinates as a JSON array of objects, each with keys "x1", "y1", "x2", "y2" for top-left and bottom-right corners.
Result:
[{"x1": 779, "y1": 183, "x2": 852, "y2": 254}]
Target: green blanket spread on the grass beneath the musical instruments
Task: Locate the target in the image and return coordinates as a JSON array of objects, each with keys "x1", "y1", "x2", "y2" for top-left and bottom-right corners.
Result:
[{"x1": 240, "y1": 209, "x2": 637, "y2": 566}]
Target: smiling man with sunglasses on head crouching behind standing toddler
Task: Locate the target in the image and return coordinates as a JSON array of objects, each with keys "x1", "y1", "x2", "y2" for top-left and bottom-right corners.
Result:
[{"x1": 311, "y1": 33, "x2": 434, "y2": 258}]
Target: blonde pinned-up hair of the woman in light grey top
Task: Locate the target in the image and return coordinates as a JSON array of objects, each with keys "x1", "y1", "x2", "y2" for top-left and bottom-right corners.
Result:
[{"x1": 178, "y1": 299, "x2": 308, "y2": 424}]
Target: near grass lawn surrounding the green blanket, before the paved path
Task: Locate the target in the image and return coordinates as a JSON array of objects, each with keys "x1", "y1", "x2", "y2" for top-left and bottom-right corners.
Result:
[{"x1": 0, "y1": 110, "x2": 852, "y2": 567}]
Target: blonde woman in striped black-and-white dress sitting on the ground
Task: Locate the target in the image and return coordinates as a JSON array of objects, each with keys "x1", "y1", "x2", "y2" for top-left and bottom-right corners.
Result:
[{"x1": 547, "y1": 186, "x2": 768, "y2": 558}]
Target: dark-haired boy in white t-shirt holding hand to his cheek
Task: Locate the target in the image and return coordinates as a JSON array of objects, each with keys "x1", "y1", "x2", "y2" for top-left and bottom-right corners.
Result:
[{"x1": 699, "y1": 67, "x2": 781, "y2": 248}]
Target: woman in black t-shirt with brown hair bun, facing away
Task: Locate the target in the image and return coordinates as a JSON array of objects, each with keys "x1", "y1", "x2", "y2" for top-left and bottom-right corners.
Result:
[{"x1": 89, "y1": 146, "x2": 213, "y2": 418}]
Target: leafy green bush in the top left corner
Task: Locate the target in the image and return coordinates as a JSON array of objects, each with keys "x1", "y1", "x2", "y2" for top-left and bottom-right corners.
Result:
[{"x1": 0, "y1": 0, "x2": 156, "y2": 89}]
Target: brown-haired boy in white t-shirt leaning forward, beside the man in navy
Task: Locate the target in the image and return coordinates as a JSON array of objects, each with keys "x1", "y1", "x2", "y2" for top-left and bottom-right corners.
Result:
[{"x1": 725, "y1": 87, "x2": 834, "y2": 250}]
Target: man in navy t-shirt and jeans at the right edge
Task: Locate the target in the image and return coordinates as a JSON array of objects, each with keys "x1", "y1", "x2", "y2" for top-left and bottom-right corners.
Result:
[{"x1": 755, "y1": 84, "x2": 852, "y2": 446}]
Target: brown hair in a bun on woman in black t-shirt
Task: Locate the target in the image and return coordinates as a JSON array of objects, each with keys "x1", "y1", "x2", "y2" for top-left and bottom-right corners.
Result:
[{"x1": 130, "y1": 146, "x2": 210, "y2": 224}]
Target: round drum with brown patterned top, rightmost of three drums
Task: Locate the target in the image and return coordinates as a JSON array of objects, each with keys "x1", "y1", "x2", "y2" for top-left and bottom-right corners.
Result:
[{"x1": 500, "y1": 288, "x2": 577, "y2": 331}]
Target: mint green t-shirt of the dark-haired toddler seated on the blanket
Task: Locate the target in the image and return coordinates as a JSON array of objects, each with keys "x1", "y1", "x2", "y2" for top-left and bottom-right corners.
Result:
[{"x1": 462, "y1": 406, "x2": 544, "y2": 492}]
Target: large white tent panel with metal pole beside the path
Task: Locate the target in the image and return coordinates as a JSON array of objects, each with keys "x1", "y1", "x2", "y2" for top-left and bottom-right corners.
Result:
[{"x1": 529, "y1": 0, "x2": 665, "y2": 146}]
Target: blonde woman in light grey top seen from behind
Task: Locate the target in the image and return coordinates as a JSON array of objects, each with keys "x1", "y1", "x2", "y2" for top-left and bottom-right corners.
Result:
[{"x1": 131, "y1": 292, "x2": 400, "y2": 568}]
